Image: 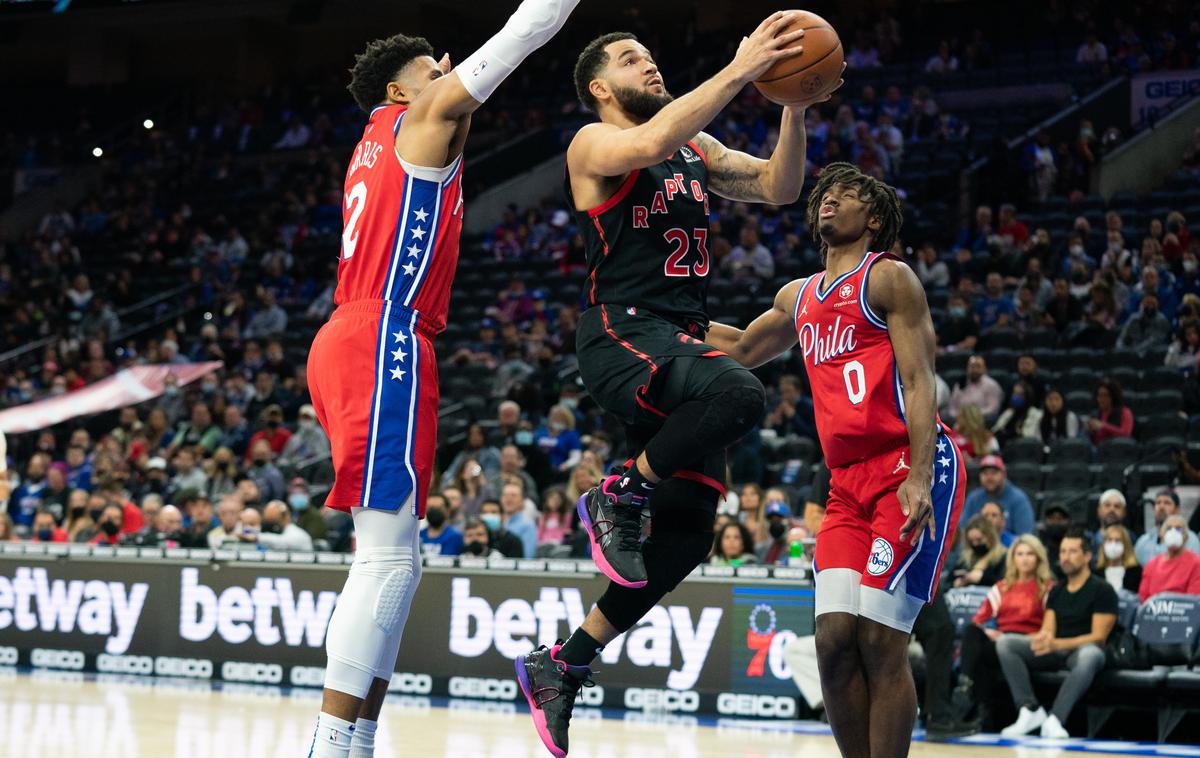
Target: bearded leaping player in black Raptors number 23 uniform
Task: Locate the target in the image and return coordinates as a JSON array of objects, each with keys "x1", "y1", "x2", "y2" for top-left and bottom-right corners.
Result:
[{"x1": 516, "y1": 12, "x2": 844, "y2": 757}]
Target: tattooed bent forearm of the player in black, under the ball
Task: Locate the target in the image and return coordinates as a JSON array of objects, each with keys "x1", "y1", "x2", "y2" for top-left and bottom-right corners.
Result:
[{"x1": 696, "y1": 65, "x2": 841, "y2": 205}]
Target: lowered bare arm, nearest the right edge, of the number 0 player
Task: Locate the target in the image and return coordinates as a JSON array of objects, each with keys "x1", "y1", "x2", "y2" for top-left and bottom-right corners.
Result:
[{"x1": 868, "y1": 260, "x2": 937, "y2": 543}]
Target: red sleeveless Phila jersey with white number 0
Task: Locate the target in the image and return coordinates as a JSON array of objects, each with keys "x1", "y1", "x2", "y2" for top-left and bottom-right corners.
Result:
[{"x1": 796, "y1": 253, "x2": 941, "y2": 469}]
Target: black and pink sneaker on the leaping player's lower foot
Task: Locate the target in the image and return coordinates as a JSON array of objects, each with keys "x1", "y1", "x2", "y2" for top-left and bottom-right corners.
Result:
[{"x1": 514, "y1": 640, "x2": 595, "y2": 758}]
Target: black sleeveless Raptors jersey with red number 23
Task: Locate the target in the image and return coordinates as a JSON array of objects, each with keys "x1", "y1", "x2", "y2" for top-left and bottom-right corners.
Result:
[{"x1": 566, "y1": 143, "x2": 710, "y2": 326}]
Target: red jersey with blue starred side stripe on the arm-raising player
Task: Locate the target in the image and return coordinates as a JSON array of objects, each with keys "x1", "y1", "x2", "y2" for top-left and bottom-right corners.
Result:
[{"x1": 334, "y1": 106, "x2": 462, "y2": 332}]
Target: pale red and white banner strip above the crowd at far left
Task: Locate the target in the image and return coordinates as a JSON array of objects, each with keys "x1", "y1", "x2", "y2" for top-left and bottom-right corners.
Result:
[{"x1": 0, "y1": 361, "x2": 222, "y2": 434}]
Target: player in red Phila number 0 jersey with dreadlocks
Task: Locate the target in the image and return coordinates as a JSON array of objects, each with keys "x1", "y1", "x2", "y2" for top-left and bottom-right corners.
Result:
[{"x1": 708, "y1": 163, "x2": 966, "y2": 758}]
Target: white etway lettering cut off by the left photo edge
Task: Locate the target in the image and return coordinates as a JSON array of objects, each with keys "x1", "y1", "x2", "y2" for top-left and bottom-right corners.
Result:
[{"x1": 0, "y1": 566, "x2": 150, "y2": 655}]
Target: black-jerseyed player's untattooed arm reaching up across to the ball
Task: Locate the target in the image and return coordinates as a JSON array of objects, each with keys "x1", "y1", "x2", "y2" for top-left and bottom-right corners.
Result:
[{"x1": 566, "y1": 11, "x2": 804, "y2": 176}]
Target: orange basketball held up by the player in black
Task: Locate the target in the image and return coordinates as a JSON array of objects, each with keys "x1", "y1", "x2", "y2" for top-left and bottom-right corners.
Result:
[{"x1": 754, "y1": 11, "x2": 844, "y2": 106}]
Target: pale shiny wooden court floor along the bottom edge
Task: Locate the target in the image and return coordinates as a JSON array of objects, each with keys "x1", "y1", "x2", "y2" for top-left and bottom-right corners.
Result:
[{"x1": 0, "y1": 669, "x2": 1200, "y2": 758}]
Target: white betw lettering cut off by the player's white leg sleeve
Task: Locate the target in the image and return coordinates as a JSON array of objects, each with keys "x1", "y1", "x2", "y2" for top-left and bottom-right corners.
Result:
[{"x1": 179, "y1": 569, "x2": 337, "y2": 648}]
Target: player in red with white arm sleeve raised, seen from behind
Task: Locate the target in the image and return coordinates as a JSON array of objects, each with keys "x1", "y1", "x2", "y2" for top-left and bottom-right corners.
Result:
[{"x1": 308, "y1": 0, "x2": 578, "y2": 758}]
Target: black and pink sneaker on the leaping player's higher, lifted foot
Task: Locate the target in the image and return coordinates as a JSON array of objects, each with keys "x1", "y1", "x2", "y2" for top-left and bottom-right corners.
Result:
[{"x1": 575, "y1": 474, "x2": 647, "y2": 589}]
